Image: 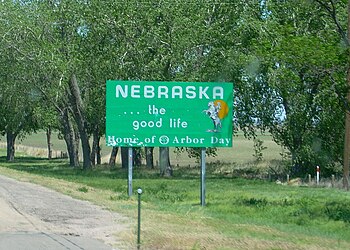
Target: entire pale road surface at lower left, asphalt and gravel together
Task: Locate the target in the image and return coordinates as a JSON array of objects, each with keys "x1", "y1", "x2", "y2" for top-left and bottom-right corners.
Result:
[{"x1": 0, "y1": 175, "x2": 127, "y2": 250}]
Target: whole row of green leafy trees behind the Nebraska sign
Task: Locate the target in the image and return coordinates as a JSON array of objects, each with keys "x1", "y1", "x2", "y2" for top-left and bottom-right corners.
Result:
[{"x1": 0, "y1": 0, "x2": 350, "y2": 187}]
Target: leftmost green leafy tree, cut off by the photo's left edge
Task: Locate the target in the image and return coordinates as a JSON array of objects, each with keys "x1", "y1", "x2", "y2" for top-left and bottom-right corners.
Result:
[{"x1": 0, "y1": 2, "x2": 38, "y2": 161}]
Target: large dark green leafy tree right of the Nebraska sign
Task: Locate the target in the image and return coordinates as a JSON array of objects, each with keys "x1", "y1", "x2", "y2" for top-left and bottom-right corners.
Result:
[{"x1": 232, "y1": 1, "x2": 345, "y2": 175}]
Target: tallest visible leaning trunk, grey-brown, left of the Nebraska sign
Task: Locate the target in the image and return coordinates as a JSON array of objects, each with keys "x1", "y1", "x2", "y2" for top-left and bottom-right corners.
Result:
[{"x1": 69, "y1": 74, "x2": 91, "y2": 169}]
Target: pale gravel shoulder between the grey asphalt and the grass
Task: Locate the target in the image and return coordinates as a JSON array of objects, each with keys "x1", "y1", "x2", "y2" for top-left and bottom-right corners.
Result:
[{"x1": 0, "y1": 175, "x2": 128, "y2": 248}]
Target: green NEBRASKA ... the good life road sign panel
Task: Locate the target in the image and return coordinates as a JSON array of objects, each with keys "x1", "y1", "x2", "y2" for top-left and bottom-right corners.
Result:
[{"x1": 106, "y1": 81, "x2": 233, "y2": 147}]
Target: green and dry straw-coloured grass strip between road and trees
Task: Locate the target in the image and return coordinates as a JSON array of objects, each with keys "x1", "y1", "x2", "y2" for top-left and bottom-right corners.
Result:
[{"x1": 0, "y1": 134, "x2": 350, "y2": 249}]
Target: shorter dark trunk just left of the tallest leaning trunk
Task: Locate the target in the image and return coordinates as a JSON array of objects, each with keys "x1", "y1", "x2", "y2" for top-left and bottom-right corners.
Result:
[{"x1": 60, "y1": 109, "x2": 79, "y2": 167}]
